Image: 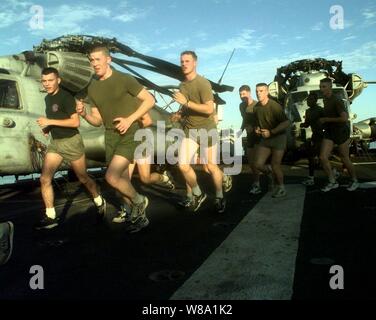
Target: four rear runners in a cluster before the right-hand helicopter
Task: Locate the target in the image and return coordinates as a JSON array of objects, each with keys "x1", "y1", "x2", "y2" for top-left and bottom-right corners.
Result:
[{"x1": 239, "y1": 78, "x2": 359, "y2": 198}]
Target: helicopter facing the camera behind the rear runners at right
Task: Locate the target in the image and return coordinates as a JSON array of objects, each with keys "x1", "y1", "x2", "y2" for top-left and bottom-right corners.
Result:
[{"x1": 269, "y1": 58, "x2": 376, "y2": 160}]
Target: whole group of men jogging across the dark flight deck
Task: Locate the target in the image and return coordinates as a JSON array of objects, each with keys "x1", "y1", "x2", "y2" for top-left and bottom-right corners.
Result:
[{"x1": 0, "y1": 47, "x2": 359, "y2": 263}]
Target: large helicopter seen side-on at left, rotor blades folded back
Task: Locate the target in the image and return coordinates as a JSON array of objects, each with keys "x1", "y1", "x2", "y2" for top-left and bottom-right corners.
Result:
[{"x1": 0, "y1": 35, "x2": 233, "y2": 176}]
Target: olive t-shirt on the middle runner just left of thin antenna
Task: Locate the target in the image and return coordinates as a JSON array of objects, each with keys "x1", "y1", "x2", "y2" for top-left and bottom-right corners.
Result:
[{"x1": 179, "y1": 75, "x2": 217, "y2": 130}]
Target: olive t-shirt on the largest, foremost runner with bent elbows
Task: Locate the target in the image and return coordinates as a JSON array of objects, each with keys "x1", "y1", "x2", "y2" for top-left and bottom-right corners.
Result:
[{"x1": 87, "y1": 70, "x2": 143, "y2": 134}]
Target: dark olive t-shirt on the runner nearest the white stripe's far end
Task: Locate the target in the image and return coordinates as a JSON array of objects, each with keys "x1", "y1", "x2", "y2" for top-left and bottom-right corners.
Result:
[{"x1": 255, "y1": 99, "x2": 288, "y2": 134}]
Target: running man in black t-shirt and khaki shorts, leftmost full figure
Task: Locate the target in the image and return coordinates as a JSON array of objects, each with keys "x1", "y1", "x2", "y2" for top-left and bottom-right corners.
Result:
[{"x1": 36, "y1": 67, "x2": 106, "y2": 229}]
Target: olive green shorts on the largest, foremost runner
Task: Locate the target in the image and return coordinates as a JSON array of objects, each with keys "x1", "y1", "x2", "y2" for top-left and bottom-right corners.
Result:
[{"x1": 104, "y1": 129, "x2": 140, "y2": 163}]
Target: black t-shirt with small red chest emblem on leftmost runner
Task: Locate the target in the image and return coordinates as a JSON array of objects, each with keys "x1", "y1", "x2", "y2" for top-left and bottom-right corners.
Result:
[{"x1": 44, "y1": 88, "x2": 79, "y2": 139}]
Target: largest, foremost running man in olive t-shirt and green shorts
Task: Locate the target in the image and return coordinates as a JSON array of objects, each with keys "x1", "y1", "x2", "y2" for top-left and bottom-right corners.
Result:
[{"x1": 76, "y1": 47, "x2": 155, "y2": 232}]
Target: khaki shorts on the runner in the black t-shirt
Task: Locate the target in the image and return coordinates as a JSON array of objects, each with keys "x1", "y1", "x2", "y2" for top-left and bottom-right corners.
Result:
[{"x1": 47, "y1": 134, "x2": 85, "y2": 162}]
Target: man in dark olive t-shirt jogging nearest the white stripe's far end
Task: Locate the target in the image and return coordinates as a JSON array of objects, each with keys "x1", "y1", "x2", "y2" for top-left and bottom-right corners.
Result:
[{"x1": 255, "y1": 83, "x2": 290, "y2": 198}]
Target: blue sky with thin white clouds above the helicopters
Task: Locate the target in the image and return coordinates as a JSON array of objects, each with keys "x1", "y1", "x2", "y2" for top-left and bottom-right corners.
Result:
[{"x1": 0, "y1": 0, "x2": 376, "y2": 127}]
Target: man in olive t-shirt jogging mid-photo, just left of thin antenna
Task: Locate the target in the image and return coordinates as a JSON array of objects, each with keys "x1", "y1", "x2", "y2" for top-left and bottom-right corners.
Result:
[{"x1": 174, "y1": 51, "x2": 226, "y2": 213}]
